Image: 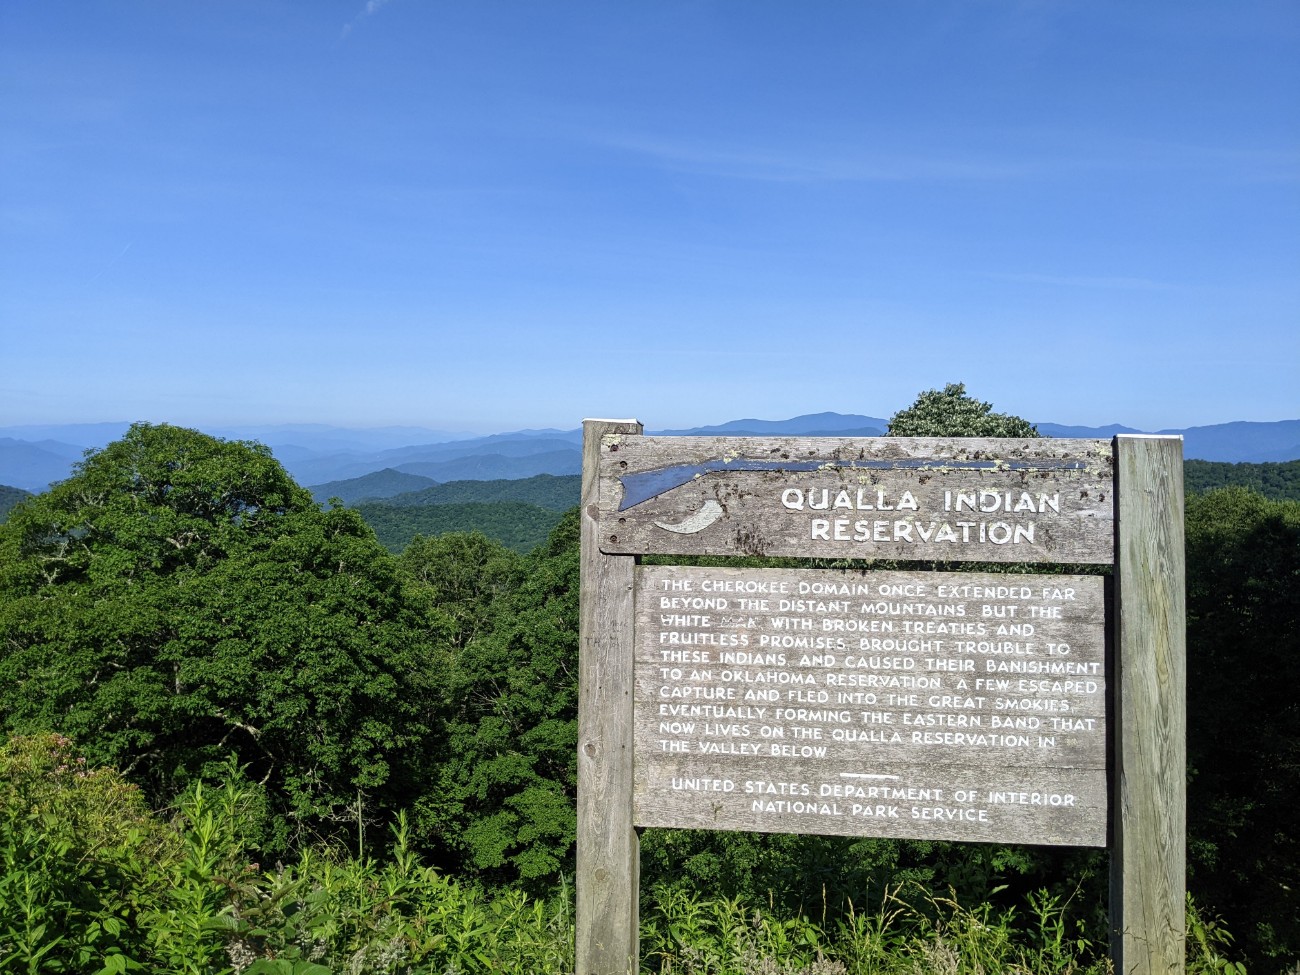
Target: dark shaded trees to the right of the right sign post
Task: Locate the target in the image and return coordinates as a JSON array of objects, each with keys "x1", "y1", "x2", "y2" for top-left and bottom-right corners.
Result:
[{"x1": 1187, "y1": 488, "x2": 1300, "y2": 961}]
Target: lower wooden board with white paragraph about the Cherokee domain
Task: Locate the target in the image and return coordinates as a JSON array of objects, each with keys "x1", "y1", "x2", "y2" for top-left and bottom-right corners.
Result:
[{"x1": 633, "y1": 567, "x2": 1106, "y2": 846}]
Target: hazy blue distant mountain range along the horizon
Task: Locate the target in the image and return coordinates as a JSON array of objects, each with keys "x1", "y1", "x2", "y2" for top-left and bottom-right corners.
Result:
[{"x1": 0, "y1": 413, "x2": 1300, "y2": 491}]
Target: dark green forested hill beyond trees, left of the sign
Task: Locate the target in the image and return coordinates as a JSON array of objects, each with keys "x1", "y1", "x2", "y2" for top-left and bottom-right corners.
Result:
[{"x1": 356, "y1": 501, "x2": 560, "y2": 554}]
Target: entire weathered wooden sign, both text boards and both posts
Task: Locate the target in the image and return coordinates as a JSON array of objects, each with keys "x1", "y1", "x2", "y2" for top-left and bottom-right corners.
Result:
[{"x1": 577, "y1": 420, "x2": 1186, "y2": 975}]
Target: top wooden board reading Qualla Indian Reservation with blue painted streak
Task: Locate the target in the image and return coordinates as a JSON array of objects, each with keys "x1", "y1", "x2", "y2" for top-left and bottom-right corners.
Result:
[{"x1": 599, "y1": 436, "x2": 1114, "y2": 563}]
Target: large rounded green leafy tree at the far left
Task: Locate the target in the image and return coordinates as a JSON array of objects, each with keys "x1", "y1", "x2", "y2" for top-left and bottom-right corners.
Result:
[{"x1": 0, "y1": 424, "x2": 439, "y2": 839}]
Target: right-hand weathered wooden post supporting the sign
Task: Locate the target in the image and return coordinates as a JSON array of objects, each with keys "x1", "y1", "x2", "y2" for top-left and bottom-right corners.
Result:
[{"x1": 1110, "y1": 437, "x2": 1187, "y2": 975}]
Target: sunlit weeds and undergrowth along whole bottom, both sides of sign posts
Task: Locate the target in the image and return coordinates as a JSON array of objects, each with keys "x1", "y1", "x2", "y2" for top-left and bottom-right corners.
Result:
[{"x1": 0, "y1": 735, "x2": 1236, "y2": 975}]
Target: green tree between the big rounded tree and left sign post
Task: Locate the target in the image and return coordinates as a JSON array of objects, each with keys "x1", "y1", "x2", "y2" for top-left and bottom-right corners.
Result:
[{"x1": 408, "y1": 510, "x2": 579, "y2": 889}]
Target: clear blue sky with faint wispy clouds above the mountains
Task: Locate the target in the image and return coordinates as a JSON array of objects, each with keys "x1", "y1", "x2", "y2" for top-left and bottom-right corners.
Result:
[{"x1": 0, "y1": 0, "x2": 1300, "y2": 432}]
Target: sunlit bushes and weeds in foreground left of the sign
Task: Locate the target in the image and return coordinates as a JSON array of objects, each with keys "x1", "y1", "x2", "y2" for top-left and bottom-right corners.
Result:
[{"x1": 0, "y1": 736, "x2": 572, "y2": 975}]
